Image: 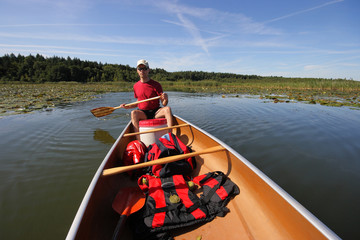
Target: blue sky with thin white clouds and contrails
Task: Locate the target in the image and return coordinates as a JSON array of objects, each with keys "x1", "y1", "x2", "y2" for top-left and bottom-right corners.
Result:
[{"x1": 0, "y1": 0, "x2": 360, "y2": 80}]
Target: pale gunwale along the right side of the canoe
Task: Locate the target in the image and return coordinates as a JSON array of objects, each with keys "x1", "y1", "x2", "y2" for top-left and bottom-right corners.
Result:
[{"x1": 176, "y1": 116, "x2": 341, "y2": 239}]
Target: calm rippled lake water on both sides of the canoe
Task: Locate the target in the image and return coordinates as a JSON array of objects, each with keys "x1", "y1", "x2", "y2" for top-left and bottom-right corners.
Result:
[{"x1": 0, "y1": 92, "x2": 360, "y2": 239}]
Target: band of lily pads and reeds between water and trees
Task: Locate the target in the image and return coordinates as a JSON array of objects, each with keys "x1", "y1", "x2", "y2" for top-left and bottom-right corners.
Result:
[{"x1": 0, "y1": 81, "x2": 360, "y2": 116}]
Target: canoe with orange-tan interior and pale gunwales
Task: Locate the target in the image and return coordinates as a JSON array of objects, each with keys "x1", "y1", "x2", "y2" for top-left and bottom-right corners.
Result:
[{"x1": 67, "y1": 116, "x2": 340, "y2": 240}]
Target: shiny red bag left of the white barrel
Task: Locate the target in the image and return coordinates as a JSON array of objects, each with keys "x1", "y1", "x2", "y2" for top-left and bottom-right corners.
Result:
[{"x1": 123, "y1": 140, "x2": 146, "y2": 175}]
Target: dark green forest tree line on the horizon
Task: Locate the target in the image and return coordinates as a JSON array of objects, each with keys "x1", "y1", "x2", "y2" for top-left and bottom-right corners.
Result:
[{"x1": 0, "y1": 54, "x2": 262, "y2": 83}]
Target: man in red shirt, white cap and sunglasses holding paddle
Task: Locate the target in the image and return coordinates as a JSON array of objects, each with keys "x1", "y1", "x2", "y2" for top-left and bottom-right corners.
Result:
[{"x1": 120, "y1": 59, "x2": 173, "y2": 132}]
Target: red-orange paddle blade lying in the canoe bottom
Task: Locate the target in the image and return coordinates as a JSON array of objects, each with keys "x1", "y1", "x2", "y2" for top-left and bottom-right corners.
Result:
[{"x1": 112, "y1": 187, "x2": 145, "y2": 216}]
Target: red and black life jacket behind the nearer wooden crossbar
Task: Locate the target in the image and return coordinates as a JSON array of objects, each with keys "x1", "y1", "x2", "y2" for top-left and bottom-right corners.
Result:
[{"x1": 145, "y1": 133, "x2": 196, "y2": 177}]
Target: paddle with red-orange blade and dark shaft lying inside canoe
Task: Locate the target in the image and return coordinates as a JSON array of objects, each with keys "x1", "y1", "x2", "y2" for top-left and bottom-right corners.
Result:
[{"x1": 112, "y1": 187, "x2": 145, "y2": 240}]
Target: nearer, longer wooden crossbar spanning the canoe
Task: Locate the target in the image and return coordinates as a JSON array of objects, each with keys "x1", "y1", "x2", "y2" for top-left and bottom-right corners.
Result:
[{"x1": 102, "y1": 145, "x2": 226, "y2": 176}]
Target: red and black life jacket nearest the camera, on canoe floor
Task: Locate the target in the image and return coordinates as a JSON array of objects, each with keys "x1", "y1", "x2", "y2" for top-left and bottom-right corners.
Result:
[{"x1": 130, "y1": 172, "x2": 240, "y2": 239}]
